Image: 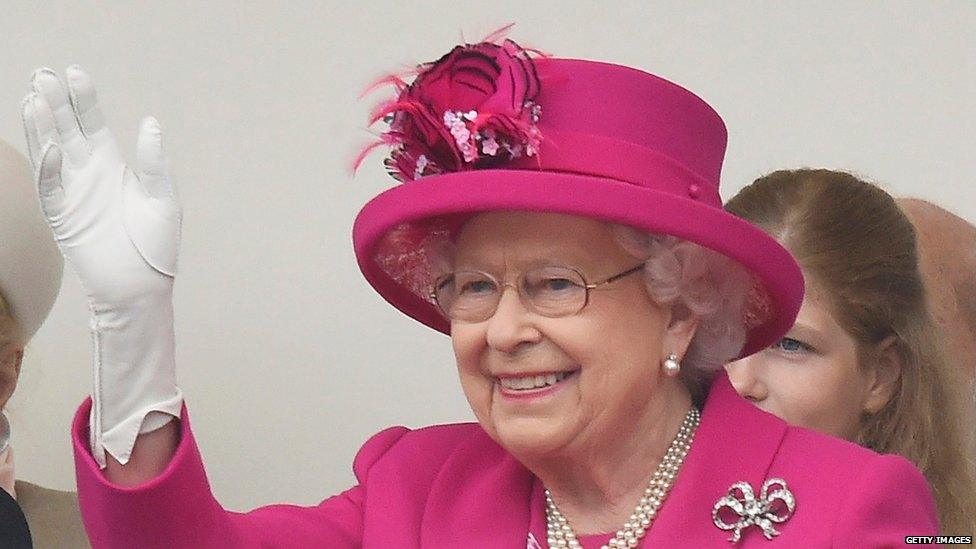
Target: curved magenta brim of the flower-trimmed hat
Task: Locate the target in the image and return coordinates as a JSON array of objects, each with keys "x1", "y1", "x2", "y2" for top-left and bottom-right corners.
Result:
[{"x1": 353, "y1": 169, "x2": 803, "y2": 357}]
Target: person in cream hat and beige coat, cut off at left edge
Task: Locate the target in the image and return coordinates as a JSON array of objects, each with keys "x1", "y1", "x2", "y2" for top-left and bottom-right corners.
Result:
[{"x1": 0, "y1": 140, "x2": 88, "y2": 549}]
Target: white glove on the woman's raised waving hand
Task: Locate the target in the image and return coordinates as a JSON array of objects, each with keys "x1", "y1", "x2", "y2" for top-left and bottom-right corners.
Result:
[{"x1": 23, "y1": 66, "x2": 183, "y2": 468}]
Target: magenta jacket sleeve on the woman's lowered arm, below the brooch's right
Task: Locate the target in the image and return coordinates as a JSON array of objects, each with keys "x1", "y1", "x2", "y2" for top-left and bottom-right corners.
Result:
[{"x1": 834, "y1": 455, "x2": 939, "y2": 547}]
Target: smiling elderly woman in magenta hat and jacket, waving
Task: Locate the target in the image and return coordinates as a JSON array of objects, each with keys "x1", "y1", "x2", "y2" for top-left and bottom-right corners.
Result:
[{"x1": 25, "y1": 38, "x2": 938, "y2": 548}]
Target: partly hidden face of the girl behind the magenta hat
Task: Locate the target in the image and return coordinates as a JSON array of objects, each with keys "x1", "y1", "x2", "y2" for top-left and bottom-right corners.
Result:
[{"x1": 725, "y1": 278, "x2": 872, "y2": 440}]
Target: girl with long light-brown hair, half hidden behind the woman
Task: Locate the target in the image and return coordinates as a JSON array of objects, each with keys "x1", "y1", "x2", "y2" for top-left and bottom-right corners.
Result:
[{"x1": 725, "y1": 169, "x2": 976, "y2": 534}]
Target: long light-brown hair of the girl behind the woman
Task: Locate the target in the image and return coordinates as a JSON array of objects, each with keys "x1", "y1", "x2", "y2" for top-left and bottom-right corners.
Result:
[{"x1": 725, "y1": 169, "x2": 976, "y2": 534}]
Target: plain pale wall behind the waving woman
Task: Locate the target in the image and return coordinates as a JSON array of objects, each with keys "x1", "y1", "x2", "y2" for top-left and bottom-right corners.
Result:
[{"x1": 0, "y1": 0, "x2": 976, "y2": 509}]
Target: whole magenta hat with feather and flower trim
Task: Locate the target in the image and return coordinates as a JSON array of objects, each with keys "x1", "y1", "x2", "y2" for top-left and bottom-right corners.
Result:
[{"x1": 353, "y1": 35, "x2": 803, "y2": 356}]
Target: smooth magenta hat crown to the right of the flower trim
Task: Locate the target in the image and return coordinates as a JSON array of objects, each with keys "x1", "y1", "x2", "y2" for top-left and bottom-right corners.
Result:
[{"x1": 536, "y1": 58, "x2": 727, "y2": 191}]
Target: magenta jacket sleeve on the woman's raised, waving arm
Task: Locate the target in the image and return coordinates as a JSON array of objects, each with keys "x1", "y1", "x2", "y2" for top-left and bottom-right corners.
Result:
[{"x1": 72, "y1": 399, "x2": 408, "y2": 549}]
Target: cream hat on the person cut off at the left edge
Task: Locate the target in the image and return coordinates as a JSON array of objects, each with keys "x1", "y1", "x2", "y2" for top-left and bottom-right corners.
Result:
[{"x1": 0, "y1": 140, "x2": 64, "y2": 340}]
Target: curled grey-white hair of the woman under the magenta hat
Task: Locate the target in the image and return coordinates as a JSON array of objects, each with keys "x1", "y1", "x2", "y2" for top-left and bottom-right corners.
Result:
[{"x1": 613, "y1": 225, "x2": 754, "y2": 381}]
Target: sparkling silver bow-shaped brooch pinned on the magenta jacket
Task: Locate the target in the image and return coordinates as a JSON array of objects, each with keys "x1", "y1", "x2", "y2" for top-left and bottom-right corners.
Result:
[{"x1": 712, "y1": 478, "x2": 796, "y2": 543}]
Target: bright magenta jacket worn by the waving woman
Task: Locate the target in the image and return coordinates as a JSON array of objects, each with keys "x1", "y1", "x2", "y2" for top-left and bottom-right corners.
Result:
[{"x1": 73, "y1": 375, "x2": 938, "y2": 549}]
